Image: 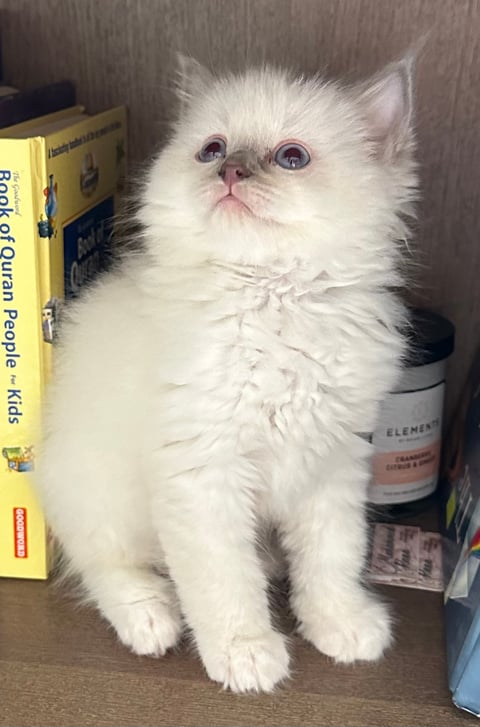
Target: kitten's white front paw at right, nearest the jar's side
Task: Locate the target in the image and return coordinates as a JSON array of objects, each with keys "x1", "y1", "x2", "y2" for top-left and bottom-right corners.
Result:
[{"x1": 301, "y1": 596, "x2": 392, "y2": 664}]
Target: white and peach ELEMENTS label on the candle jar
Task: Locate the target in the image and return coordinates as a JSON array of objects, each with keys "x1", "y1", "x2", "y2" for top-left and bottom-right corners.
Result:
[{"x1": 369, "y1": 382, "x2": 445, "y2": 504}]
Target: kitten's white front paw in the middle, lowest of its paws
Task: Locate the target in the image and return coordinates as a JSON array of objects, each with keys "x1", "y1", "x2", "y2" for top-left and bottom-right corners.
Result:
[{"x1": 202, "y1": 631, "x2": 289, "y2": 692}]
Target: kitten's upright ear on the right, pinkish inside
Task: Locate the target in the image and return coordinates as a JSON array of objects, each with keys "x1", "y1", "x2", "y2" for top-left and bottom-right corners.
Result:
[{"x1": 358, "y1": 57, "x2": 413, "y2": 159}]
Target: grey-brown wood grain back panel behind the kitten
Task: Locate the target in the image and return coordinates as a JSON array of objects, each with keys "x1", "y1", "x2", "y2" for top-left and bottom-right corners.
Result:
[{"x1": 0, "y1": 0, "x2": 480, "y2": 416}]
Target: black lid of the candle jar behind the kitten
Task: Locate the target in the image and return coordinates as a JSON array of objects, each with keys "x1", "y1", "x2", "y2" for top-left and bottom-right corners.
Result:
[{"x1": 408, "y1": 308, "x2": 455, "y2": 366}]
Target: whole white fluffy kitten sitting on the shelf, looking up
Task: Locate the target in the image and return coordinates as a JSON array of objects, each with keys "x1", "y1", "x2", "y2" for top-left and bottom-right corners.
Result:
[{"x1": 38, "y1": 55, "x2": 416, "y2": 691}]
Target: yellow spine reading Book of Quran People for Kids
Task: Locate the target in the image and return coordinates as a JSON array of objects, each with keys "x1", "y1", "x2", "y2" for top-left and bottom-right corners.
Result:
[{"x1": 0, "y1": 139, "x2": 48, "y2": 578}]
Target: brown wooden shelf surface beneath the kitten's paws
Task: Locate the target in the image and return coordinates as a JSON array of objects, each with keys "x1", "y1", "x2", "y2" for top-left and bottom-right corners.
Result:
[{"x1": 0, "y1": 579, "x2": 480, "y2": 727}]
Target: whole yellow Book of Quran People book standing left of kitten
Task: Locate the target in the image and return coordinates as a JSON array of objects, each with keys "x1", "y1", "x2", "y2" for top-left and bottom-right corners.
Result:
[{"x1": 0, "y1": 107, "x2": 127, "y2": 578}]
